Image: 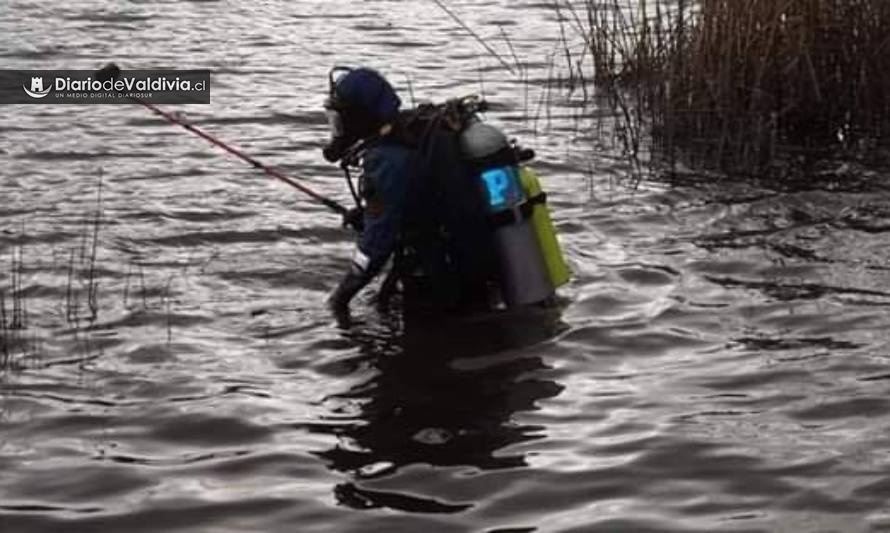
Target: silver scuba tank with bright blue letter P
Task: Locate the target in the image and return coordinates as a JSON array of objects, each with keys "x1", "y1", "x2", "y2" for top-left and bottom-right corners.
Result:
[{"x1": 460, "y1": 121, "x2": 555, "y2": 307}]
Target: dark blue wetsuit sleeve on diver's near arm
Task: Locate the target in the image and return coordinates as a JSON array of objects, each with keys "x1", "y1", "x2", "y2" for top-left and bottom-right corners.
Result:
[{"x1": 356, "y1": 147, "x2": 410, "y2": 277}]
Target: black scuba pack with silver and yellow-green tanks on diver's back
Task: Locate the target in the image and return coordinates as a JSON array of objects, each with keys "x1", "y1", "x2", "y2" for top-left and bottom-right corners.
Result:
[{"x1": 344, "y1": 96, "x2": 569, "y2": 309}]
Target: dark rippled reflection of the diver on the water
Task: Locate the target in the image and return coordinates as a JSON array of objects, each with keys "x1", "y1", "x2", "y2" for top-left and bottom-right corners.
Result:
[{"x1": 308, "y1": 311, "x2": 562, "y2": 513}]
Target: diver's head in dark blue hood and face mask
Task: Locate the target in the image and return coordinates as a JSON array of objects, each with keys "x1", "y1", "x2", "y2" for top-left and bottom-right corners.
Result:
[{"x1": 323, "y1": 67, "x2": 402, "y2": 163}]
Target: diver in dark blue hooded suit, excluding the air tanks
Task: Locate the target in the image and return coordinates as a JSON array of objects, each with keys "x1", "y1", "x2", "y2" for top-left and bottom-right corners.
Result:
[{"x1": 323, "y1": 67, "x2": 495, "y2": 315}]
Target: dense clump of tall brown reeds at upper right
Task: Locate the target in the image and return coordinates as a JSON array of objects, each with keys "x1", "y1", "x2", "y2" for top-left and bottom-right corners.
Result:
[{"x1": 583, "y1": 0, "x2": 890, "y2": 176}]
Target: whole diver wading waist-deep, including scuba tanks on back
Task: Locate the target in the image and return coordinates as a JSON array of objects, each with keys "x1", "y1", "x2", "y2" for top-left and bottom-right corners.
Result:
[{"x1": 323, "y1": 67, "x2": 568, "y2": 316}]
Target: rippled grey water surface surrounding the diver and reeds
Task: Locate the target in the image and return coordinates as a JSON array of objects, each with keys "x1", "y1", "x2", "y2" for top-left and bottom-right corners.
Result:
[{"x1": 0, "y1": 0, "x2": 890, "y2": 532}]
